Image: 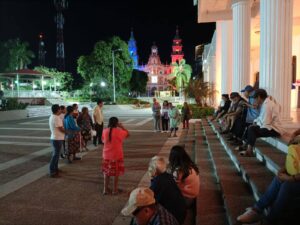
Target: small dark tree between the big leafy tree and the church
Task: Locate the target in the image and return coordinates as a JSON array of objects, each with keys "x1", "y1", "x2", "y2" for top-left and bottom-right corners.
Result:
[{"x1": 130, "y1": 70, "x2": 148, "y2": 96}]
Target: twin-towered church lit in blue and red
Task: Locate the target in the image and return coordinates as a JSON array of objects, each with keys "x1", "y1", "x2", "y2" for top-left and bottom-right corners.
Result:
[{"x1": 128, "y1": 28, "x2": 184, "y2": 96}]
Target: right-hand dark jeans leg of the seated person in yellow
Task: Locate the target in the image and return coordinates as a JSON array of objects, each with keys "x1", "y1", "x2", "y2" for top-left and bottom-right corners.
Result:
[{"x1": 266, "y1": 178, "x2": 300, "y2": 224}]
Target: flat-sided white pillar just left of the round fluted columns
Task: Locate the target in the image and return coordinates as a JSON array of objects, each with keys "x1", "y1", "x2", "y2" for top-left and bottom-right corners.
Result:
[{"x1": 220, "y1": 20, "x2": 233, "y2": 94}]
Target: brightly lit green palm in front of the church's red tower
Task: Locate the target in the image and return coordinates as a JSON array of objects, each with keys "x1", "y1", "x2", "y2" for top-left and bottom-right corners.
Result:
[{"x1": 171, "y1": 59, "x2": 192, "y2": 99}]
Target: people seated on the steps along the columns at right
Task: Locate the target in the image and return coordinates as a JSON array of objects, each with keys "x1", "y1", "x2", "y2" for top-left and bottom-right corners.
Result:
[{"x1": 212, "y1": 85, "x2": 300, "y2": 224}]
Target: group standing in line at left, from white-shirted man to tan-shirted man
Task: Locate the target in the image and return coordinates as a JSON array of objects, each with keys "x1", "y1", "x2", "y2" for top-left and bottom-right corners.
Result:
[{"x1": 49, "y1": 100, "x2": 103, "y2": 177}]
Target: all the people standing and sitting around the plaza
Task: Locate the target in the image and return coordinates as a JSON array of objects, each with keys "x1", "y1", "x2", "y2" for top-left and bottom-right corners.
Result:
[{"x1": 49, "y1": 92, "x2": 300, "y2": 225}]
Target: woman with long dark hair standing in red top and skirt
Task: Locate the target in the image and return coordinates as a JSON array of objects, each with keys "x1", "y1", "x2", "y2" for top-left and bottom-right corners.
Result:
[{"x1": 102, "y1": 117, "x2": 129, "y2": 195}]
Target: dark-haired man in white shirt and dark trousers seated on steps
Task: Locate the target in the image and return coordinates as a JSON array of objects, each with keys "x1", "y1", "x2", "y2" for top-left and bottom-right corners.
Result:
[{"x1": 240, "y1": 89, "x2": 283, "y2": 157}]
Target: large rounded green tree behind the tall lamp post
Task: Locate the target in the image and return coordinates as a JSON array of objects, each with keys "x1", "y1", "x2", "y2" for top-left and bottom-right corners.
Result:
[{"x1": 77, "y1": 36, "x2": 133, "y2": 98}]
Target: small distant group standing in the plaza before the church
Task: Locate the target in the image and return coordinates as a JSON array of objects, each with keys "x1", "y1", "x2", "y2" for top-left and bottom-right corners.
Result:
[{"x1": 152, "y1": 98, "x2": 192, "y2": 137}]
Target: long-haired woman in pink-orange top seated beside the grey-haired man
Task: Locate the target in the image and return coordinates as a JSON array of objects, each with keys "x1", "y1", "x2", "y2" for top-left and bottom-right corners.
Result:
[{"x1": 169, "y1": 145, "x2": 200, "y2": 207}]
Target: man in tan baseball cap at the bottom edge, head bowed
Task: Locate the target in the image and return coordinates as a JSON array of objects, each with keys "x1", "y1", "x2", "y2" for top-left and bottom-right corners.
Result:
[{"x1": 122, "y1": 187, "x2": 179, "y2": 225}]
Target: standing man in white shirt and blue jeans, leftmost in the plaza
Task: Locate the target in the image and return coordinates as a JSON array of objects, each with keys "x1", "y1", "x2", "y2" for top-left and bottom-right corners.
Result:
[{"x1": 49, "y1": 104, "x2": 65, "y2": 178}]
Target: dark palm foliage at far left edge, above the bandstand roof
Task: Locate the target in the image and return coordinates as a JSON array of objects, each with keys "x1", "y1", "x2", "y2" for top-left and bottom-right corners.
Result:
[{"x1": 0, "y1": 38, "x2": 35, "y2": 72}]
